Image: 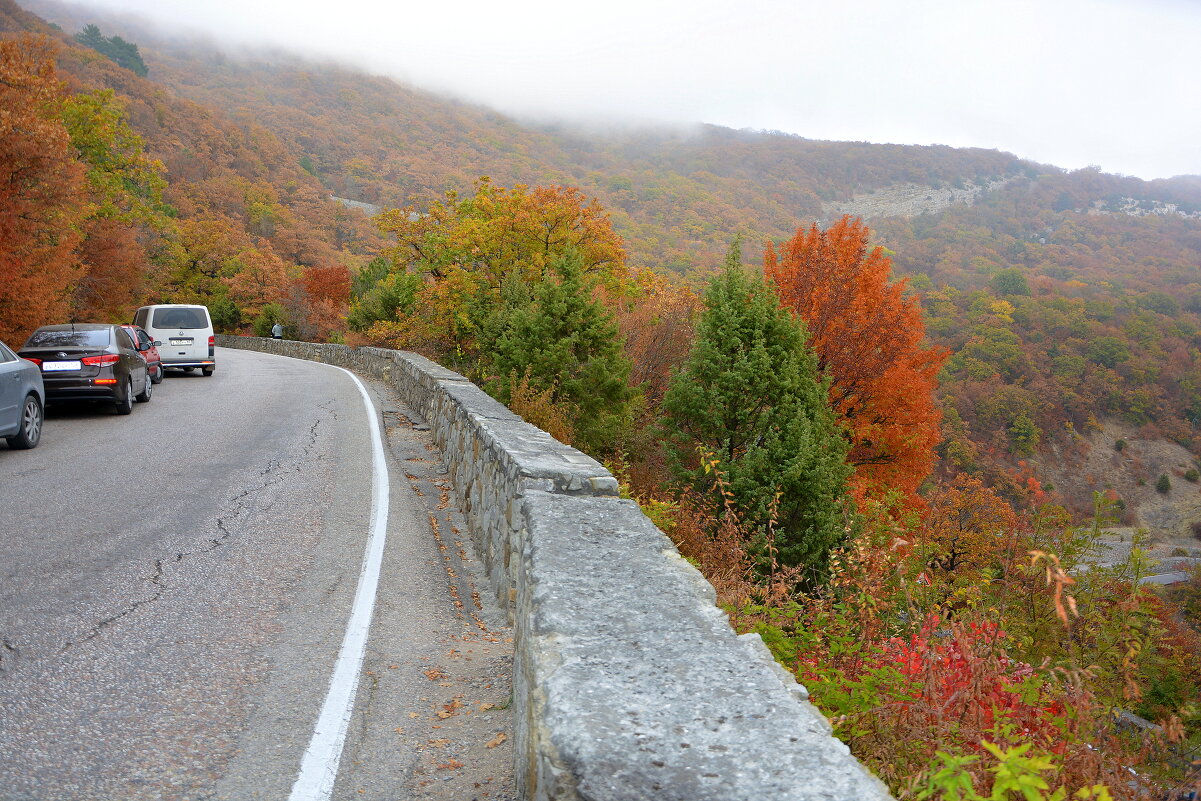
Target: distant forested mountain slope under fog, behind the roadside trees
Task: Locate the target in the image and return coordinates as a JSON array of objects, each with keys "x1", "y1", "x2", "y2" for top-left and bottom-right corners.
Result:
[{"x1": 14, "y1": 0, "x2": 1201, "y2": 521}]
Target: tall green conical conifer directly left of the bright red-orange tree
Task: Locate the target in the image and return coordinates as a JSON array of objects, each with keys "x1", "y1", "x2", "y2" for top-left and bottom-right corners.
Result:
[{"x1": 663, "y1": 244, "x2": 850, "y2": 578}]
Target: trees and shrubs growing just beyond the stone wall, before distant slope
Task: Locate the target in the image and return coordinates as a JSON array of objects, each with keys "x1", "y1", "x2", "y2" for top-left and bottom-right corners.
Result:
[{"x1": 352, "y1": 181, "x2": 1201, "y2": 799}]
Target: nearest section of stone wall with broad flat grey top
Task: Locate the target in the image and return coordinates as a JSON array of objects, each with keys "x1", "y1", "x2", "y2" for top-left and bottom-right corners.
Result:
[{"x1": 514, "y1": 491, "x2": 890, "y2": 801}]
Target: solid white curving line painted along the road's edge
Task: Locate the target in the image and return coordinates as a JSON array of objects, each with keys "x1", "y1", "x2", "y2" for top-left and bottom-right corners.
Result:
[{"x1": 288, "y1": 365, "x2": 389, "y2": 801}]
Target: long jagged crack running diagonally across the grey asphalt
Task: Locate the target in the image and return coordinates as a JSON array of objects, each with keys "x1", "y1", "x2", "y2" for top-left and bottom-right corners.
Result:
[{"x1": 56, "y1": 410, "x2": 337, "y2": 653}]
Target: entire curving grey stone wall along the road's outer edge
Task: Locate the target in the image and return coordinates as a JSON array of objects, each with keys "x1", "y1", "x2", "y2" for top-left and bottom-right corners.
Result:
[{"x1": 217, "y1": 336, "x2": 890, "y2": 801}]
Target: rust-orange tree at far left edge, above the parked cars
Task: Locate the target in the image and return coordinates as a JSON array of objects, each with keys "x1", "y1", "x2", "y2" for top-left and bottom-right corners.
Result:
[{"x1": 0, "y1": 36, "x2": 86, "y2": 346}]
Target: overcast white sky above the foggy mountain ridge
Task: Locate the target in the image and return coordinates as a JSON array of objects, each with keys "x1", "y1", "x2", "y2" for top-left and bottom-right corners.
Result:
[{"x1": 68, "y1": 0, "x2": 1201, "y2": 179}]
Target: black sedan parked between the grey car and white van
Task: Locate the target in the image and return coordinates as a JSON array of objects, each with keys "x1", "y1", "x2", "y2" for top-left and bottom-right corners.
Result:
[{"x1": 19, "y1": 323, "x2": 154, "y2": 414}]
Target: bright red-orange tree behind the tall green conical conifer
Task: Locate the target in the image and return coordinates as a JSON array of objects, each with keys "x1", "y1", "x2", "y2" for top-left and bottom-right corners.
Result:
[{"x1": 764, "y1": 216, "x2": 948, "y2": 507}]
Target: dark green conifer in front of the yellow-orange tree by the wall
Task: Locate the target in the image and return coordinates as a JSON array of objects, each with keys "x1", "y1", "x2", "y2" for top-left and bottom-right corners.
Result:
[{"x1": 489, "y1": 251, "x2": 637, "y2": 455}]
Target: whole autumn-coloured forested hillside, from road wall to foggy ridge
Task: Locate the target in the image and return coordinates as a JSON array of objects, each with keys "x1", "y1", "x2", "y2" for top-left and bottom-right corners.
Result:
[{"x1": 7, "y1": 0, "x2": 1201, "y2": 801}]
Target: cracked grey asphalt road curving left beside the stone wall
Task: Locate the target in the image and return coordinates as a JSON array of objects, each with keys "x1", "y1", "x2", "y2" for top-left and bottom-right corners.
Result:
[{"x1": 0, "y1": 349, "x2": 510, "y2": 801}]
